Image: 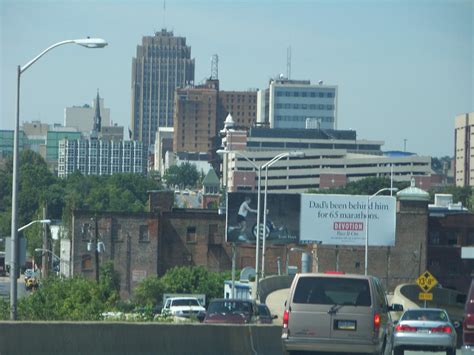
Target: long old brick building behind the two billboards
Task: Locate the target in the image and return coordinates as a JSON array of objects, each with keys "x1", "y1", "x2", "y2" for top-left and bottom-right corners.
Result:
[{"x1": 71, "y1": 186, "x2": 474, "y2": 298}]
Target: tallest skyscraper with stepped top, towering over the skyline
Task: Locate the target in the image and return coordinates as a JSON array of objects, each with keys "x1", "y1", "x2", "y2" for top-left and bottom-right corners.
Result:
[{"x1": 131, "y1": 29, "x2": 194, "y2": 149}]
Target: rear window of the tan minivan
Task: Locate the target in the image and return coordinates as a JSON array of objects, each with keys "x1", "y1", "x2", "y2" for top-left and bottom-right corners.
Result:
[{"x1": 293, "y1": 277, "x2": 372, "y2": 306}]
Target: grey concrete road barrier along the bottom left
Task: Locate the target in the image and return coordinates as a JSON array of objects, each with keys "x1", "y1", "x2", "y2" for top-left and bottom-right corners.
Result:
[{"x1": 0, "y1": 321, "x2": 282, "y2": 355}]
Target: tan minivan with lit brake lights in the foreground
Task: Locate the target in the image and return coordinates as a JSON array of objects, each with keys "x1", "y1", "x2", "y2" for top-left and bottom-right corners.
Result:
[{"x1": 282, "y1": 272, "x2": 403, "y2": 354}]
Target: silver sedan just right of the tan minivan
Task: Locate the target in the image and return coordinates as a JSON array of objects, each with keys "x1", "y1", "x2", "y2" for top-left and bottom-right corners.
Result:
[{"x1": 393, "y1": 308, "x2": 457, "y2": 355}]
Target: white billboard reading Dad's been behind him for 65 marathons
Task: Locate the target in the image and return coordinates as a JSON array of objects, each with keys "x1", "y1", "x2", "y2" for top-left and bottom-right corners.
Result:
[{"x1": 300, "y1": 194, "x2": 396, "y2": 246}]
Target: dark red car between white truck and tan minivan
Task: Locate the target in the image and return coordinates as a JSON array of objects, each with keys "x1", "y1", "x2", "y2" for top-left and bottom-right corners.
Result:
[{"x1": 203, "y1": 298, "x2": 258, "y2": 324}]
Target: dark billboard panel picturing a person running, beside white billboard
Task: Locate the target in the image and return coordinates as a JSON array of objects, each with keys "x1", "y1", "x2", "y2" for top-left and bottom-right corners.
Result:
[{"x1": 226, "y1": 192, "x2": 301, "y2": 243}]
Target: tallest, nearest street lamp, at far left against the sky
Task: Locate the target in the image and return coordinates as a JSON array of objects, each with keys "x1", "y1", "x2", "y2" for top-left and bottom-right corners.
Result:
[{"x1": 10, "y1": 37, "x2": 107, "y2": 320}]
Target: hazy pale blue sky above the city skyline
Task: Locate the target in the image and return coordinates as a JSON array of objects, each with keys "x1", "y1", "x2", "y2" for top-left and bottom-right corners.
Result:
[{"x1": 0, "y1": 0, "x2": 474, "y2": 157}]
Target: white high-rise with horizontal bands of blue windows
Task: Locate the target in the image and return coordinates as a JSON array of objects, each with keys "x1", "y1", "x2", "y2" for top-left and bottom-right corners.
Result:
[{"x1": 258, "y1": 78, "x2": 337, "y2": 129}]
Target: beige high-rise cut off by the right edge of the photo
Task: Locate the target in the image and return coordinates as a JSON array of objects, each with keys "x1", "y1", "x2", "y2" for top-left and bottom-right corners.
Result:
[{"x1": 454, "y1": 112, "x2": 474, "y2": 186}]
